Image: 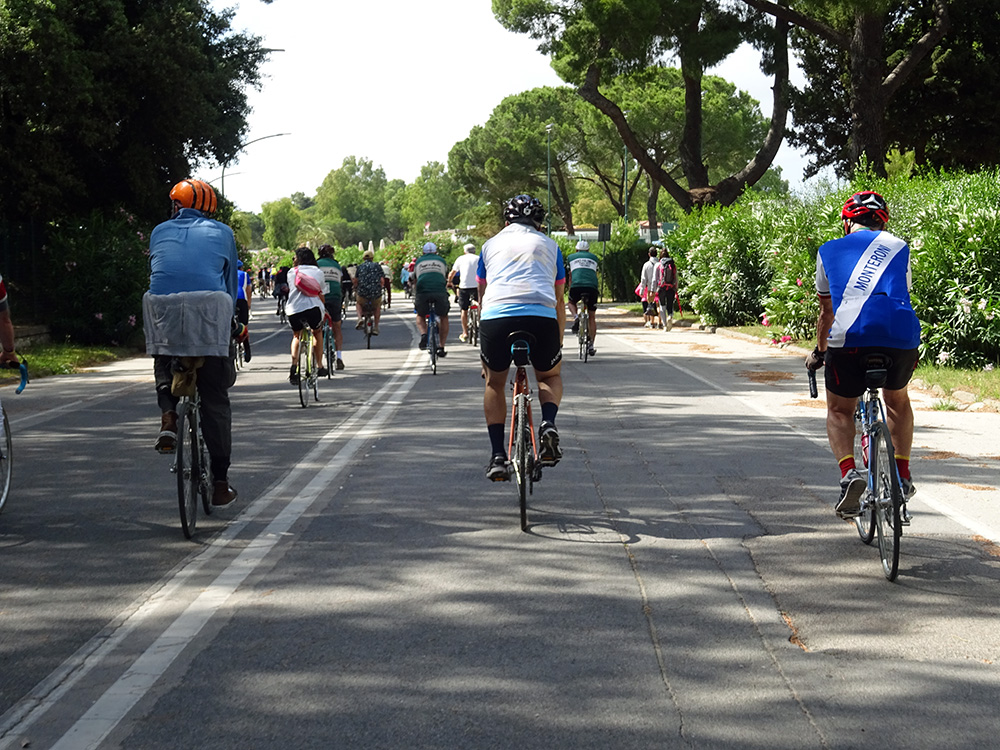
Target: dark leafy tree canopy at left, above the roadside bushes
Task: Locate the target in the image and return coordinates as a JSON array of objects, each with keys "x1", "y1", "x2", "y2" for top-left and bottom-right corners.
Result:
[{"x1": 0, "y1": 0, "x2": 267, "y2": 226}]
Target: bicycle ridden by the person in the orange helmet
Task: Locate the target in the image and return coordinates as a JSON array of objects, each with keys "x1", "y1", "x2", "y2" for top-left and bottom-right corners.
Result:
[{"x1": 170, "y1": 357, "x2": 214, "y2": 539}]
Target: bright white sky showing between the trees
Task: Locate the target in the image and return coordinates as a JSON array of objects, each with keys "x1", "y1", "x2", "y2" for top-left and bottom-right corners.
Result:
[{"x1": 207, "y1": 0, "x2": 805, "y2": 212}]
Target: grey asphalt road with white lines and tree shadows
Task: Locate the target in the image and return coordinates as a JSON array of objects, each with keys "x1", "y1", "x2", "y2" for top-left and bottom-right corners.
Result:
[{"x1": 0, "y1": 301, "x2": 1000, "y2": 750}]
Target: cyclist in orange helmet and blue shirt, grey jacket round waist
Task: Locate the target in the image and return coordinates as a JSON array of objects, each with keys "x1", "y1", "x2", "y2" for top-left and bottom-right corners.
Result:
[{"x1": 143, "y1": 180, "x2": 237, "y2": 507}]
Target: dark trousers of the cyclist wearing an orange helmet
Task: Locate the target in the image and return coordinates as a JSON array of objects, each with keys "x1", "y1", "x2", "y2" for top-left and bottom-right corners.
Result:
[{"x1": 153, "y1": 355, "x2": 236, "y2": 481}]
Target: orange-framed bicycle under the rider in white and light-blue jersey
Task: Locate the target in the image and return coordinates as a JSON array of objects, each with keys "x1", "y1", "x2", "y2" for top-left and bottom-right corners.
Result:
[{"x1": 507, "y1": 331, "x2": 542, "y2": 531}]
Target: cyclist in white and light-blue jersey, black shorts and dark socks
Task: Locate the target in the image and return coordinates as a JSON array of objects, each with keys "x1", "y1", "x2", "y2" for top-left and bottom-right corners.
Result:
[{"x1": 476, "y1": 195, "x2": 566, "y2": 482}]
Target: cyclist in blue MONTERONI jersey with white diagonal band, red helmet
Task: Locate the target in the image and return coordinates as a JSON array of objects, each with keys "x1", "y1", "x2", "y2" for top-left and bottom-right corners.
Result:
[{"x1": 806, "y1": 190, "x2": 920, "y2": 518}]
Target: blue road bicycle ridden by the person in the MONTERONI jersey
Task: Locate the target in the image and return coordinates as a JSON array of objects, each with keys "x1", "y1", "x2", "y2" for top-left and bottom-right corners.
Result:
[{"x1": 809, "y1": 353, "x2": 910, "y2": 581}]
